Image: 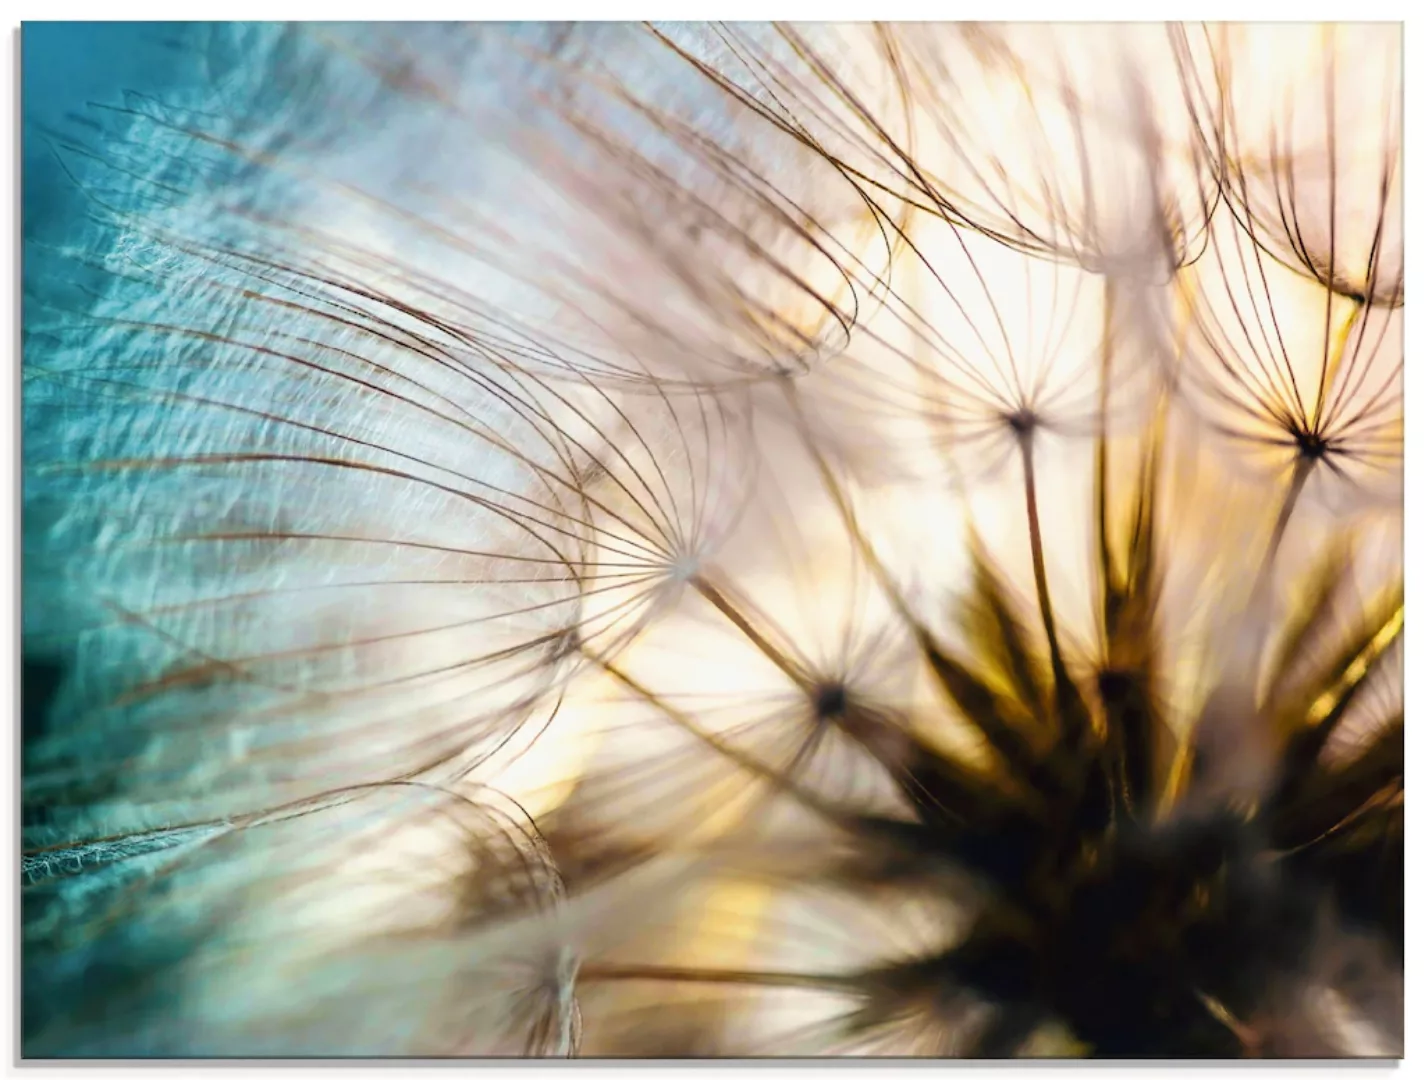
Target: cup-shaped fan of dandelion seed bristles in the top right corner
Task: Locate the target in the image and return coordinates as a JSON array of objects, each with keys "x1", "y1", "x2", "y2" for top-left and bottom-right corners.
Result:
[{"x1": 1173, "y1": 24, "x2": 1405, "y2": 306}]
